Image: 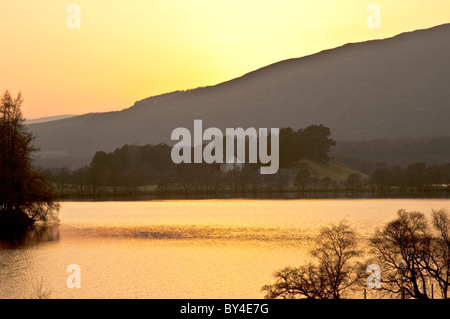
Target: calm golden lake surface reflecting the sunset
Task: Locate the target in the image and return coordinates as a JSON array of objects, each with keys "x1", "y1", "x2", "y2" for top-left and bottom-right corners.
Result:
[{"x1": 0, "y1": 199, "x2": 450, "y2": 298}]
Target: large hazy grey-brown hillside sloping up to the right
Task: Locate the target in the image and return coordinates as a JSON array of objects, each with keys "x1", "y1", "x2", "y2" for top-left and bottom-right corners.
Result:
[{"x1": 29, "y1": 24, "x2": 450, "y2": 168}]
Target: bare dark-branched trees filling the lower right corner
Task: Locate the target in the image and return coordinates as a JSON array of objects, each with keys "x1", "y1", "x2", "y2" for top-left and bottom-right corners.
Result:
[{"x1": 371, "y1": 210, "x2": 450, "y2": 299}]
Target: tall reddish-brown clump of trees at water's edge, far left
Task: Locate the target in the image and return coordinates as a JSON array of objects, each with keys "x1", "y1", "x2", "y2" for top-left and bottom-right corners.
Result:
[{"x1": 0, "y1": 91, "x2": 59, "y2": 229}]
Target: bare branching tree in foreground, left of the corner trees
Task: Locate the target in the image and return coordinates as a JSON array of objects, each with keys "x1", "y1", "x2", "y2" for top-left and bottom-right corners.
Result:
[{"x1": 262, "y1": 222, "x2": 361, "y2": 299}]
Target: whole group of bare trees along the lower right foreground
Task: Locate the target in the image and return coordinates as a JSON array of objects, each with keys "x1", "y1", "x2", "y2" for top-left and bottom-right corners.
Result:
[{"x1": 262, "y1": 209, "x2": 450, "y2": 299}]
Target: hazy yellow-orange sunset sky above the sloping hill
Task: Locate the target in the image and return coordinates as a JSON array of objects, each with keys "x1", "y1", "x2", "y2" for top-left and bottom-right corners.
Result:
[{"x1": 0, "y1": 0, "x2": 450, "y2": 119}]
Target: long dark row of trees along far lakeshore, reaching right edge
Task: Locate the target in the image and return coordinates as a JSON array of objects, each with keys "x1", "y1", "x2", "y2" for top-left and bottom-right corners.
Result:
[{"x1": 41, "y1": 154, "x2": 450, "y2": 198}]
